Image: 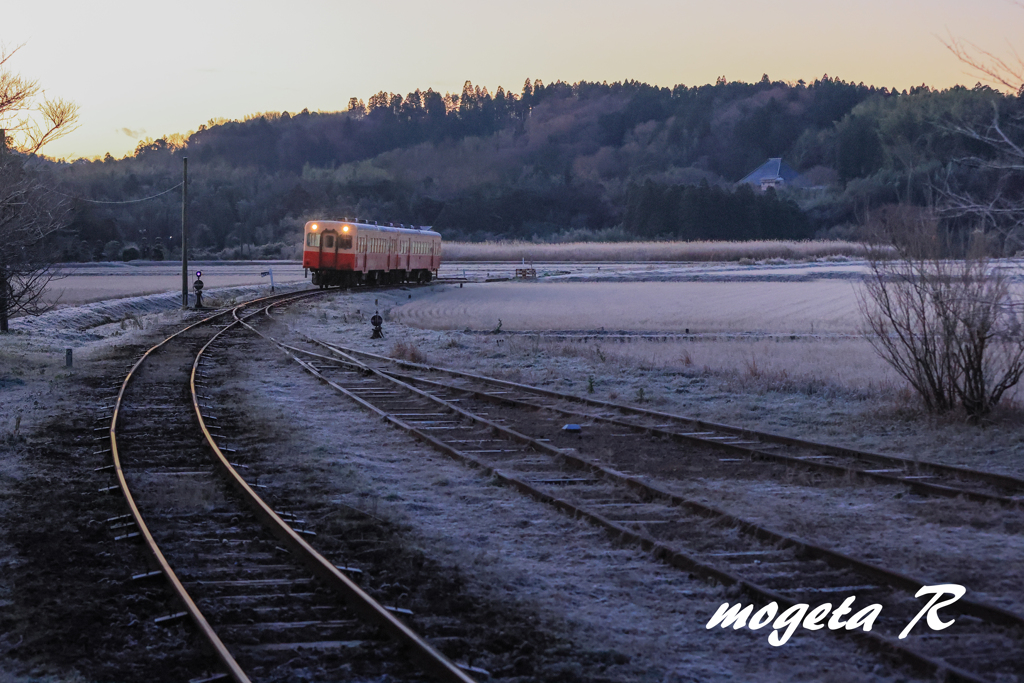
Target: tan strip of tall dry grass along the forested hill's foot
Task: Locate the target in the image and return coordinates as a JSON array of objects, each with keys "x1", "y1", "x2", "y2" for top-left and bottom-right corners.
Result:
[{"x1": 444, "y1": 240, "x2": 864, "y2": 261}]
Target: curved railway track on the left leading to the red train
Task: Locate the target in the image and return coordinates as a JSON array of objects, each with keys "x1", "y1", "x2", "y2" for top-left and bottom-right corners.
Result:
[{"x1": 103, "y1": 292, "x2": 472, "y2": 683}]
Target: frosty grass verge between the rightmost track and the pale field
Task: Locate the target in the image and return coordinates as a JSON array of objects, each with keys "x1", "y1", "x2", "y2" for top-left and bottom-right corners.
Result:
[{"x1": 293, "y1": 284, "x2": 1024, "y2": 477}]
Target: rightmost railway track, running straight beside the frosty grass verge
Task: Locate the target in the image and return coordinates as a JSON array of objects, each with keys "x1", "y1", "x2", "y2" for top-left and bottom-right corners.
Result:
[{"x1": 313, "y1": 340, "x2": 1024, "y2": 508}]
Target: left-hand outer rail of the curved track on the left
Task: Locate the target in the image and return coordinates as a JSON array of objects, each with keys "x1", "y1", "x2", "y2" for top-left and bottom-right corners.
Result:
[{"x1": 110, "y1": 292, "x2": 318, "y2": 683}]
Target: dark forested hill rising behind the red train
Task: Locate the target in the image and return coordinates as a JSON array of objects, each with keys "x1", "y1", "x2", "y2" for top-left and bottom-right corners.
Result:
[{"x1": 46, "y1": 76, "x2": 1007, "y2": 259}]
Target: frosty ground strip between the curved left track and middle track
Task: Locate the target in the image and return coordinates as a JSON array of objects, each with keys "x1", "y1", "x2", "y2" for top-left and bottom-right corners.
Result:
[{"x1": 221, "y1": 327, "x2": 929, "y2": 683}]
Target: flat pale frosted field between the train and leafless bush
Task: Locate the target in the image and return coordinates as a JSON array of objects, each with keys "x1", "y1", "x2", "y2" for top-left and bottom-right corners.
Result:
[{"x1": 392, "y1": 280, "x2": 860, "y2": 334}]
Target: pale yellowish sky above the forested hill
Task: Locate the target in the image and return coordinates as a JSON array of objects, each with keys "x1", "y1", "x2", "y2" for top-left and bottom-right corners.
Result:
[{"x1": 0, "y1": 0, "x2": 1024, "y2": 159}]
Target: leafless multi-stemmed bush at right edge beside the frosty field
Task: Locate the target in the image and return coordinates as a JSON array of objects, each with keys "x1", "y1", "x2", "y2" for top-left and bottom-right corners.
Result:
[{"x1": 860, "y1": 206, "x2": 1024, "y2": 420}]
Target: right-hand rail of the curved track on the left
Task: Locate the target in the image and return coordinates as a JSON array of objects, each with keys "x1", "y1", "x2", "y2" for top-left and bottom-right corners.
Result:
[{"x1": 219, "y1": 305, "x2": 474, "y2": 683}]
